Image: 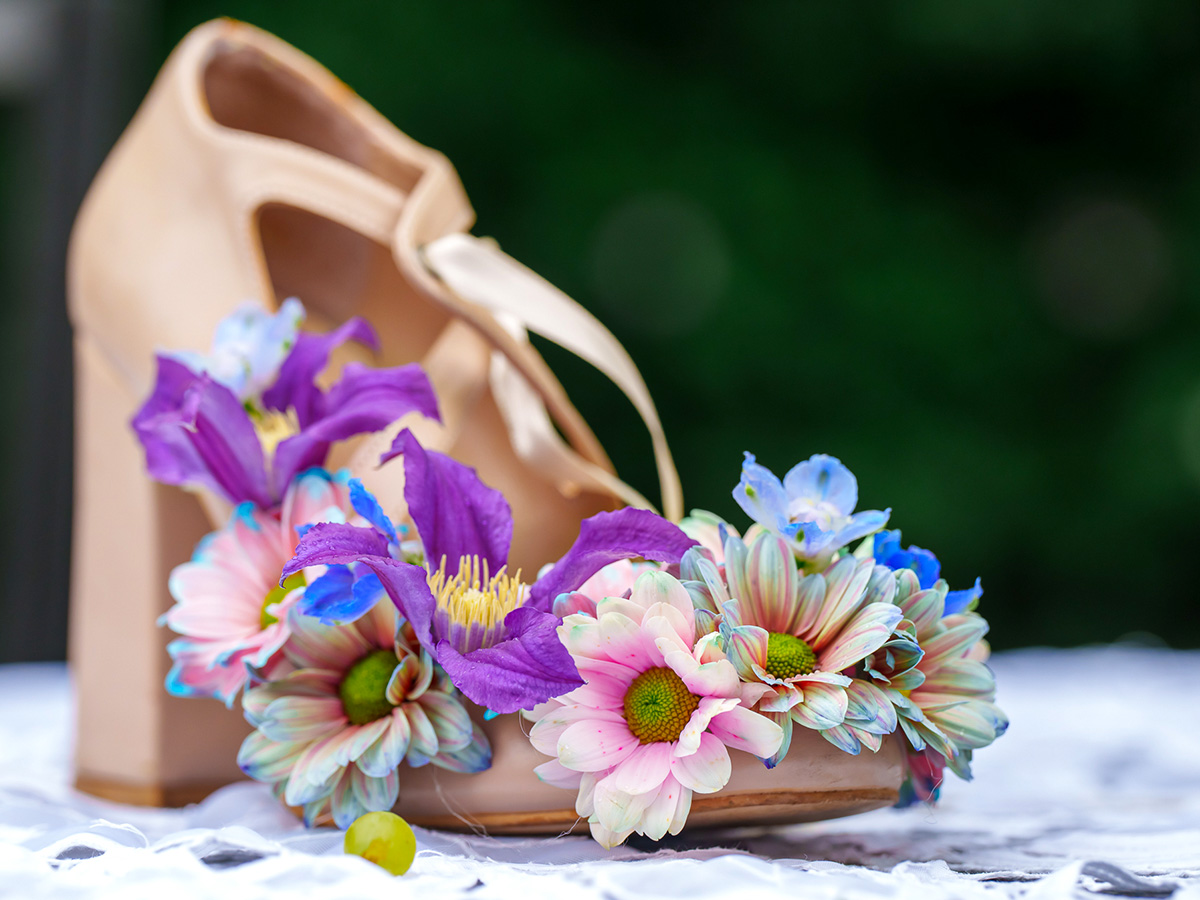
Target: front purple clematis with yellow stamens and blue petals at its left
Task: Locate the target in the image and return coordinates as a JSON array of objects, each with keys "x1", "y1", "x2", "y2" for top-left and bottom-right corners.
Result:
[{"x1": 282, "y1": 430, "x2": 696, "y2": 713}]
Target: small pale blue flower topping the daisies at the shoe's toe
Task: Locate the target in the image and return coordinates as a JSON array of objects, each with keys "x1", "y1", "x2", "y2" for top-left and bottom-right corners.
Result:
[{"x1": 733, "y1": 452, "x2": 892, "y2": 571}]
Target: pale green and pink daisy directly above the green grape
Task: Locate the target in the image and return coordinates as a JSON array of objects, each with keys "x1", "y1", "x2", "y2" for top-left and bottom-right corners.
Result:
[{"x1": 238, "y1": 604, "x2": 492, "y2": 828}]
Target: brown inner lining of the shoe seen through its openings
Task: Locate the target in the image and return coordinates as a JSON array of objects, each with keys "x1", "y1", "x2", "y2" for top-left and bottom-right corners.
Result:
[{"x1": 204, "y1": 44, "x2": 614, "y2": 571}]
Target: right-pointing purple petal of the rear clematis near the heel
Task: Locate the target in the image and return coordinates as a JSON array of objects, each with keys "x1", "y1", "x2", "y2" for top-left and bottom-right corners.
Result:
[{"x1": 271, "y1": 362, "x2": 439, "y2": 492}]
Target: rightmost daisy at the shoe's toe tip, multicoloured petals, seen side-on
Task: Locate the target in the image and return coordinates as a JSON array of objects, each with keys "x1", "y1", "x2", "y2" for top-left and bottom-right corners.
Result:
[{"x1": 862, "y1": 566, "x2": 1008, "y2": 802}]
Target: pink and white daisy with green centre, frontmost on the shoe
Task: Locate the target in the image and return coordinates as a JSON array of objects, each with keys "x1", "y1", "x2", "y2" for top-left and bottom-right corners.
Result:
[{"x1": 529, "y1": 571, "x2": 784, "y2": 847}]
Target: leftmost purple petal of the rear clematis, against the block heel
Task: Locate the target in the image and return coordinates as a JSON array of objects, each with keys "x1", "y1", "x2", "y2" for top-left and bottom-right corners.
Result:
[{"x1": 132, "y1": 356, "x2": 274, "y2": 508}]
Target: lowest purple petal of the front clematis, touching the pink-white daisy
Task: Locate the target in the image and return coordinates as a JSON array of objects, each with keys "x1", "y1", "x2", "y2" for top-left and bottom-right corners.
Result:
[{"x1": 436, "y1": 607, "x2": 583, "y2": 713}]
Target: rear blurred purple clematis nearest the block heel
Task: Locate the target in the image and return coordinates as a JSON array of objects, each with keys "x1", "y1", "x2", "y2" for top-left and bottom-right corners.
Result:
[{"x1": 132, "y1": 318, "x2": 438, "y2": 509}]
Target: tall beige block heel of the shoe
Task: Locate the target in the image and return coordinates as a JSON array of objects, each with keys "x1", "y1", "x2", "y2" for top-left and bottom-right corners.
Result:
[{"x1": 70, "y1": 335, "x2": 250, "y2": 806}]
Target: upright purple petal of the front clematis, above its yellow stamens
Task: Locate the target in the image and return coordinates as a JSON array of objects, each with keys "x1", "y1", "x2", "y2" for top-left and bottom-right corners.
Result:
[{"x1": 380, "y1": 428, "x2": 513, "y2": 573}]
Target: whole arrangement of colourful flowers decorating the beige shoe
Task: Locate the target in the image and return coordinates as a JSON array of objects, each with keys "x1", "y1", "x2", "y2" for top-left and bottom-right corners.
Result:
[{"x1": 133, "y1": 301, "x2": 1007, "y2": 846}]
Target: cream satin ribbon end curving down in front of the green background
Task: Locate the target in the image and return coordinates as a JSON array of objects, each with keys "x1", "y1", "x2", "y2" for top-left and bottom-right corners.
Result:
[{"x1": 424, "y1": 234, "x2": 683, "y2": 521}]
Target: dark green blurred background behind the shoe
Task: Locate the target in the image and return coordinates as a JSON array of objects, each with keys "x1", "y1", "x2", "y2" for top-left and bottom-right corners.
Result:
[{"x1": 0, "y1": 0, "x2": 1200, "y2": 658}]
